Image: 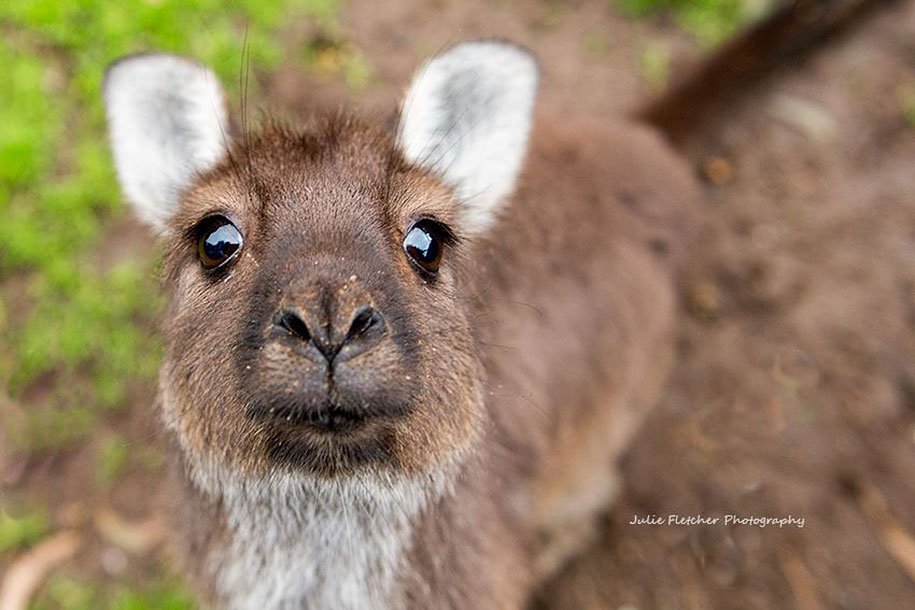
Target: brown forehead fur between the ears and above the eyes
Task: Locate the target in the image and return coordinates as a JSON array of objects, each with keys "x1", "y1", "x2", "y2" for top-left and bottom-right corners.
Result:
[{"x1": 171, "y1": 114, "x2": 461, "y2": 240}]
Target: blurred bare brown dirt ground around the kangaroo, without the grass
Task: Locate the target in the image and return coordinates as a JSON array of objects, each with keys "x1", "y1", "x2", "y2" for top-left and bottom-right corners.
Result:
[{"x1": 7, "y1": 0, "x2": 915, "y2": 610}]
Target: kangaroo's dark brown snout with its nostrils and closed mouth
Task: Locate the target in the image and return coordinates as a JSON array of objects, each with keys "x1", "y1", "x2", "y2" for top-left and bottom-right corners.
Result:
[{"x1": 242, "y1": 268, "x2": 409, "y2": 446}]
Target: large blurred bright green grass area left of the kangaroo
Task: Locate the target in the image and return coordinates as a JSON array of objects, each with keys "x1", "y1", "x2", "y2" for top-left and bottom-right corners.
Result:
[{"x1": 0, "y1": 0, "x2": 340, "y2": 450}]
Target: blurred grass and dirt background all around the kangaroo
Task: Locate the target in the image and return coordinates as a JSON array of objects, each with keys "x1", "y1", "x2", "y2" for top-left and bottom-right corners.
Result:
[{"x1": 0, "y1": 0, "x2": 915, "y2": 610}]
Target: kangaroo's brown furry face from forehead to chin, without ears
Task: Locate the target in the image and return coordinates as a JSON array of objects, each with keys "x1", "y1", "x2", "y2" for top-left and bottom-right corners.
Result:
[{"x1": 157, "y1": 123, "x2": 482, "y2": 476}]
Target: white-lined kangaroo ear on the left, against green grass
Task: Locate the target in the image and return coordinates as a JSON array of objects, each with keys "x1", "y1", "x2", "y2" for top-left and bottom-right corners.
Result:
[{"x1": 103, "y1": 55, "x2": 228, "y2": 231}]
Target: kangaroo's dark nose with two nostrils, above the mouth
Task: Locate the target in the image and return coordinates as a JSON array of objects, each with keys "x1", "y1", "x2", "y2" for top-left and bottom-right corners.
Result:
[{"x1": 274, "y1": 305, "x2": 385, "y2": 363}]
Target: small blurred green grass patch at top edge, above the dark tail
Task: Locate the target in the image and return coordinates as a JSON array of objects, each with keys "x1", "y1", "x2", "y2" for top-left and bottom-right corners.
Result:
[{"x1": 615, "y1": 0, "x2": 766, "y2": 46}]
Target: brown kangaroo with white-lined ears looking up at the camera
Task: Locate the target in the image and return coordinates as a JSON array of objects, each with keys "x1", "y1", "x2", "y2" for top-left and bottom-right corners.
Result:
[{"x1": 104, "y1": 2, "x2": 896, "y2": 610}]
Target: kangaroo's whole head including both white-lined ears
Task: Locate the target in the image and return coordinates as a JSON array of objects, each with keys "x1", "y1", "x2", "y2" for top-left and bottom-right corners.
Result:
[{"x1": 105, "y1": 42, "x2": 536, "y2": 479}]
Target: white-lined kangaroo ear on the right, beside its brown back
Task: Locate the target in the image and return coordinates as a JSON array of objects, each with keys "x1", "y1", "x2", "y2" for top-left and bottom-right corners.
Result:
[{"x1": 398, "y1": 41, "x2": 538, "y2": 232}]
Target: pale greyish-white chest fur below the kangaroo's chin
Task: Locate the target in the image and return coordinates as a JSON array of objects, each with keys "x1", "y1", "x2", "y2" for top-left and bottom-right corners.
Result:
[{"x1": 198, "y1": 464, "x2": 441, "y2": 610}]
